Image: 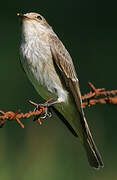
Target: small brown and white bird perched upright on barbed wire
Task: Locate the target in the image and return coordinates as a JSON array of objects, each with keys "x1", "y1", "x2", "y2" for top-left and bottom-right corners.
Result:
[{"x1": 17, "y1": 12, "x2": 104, "y2": 169}]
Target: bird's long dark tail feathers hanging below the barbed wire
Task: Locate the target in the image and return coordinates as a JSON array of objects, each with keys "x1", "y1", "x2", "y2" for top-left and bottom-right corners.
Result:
[{"x1": 83, "y1": 118, "x2": 104, "y2": 169}]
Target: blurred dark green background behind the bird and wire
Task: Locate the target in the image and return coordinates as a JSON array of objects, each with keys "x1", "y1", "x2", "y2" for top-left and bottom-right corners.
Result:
[{"x1": 0, "y1": 0, "x2": 117, "y2": 180}]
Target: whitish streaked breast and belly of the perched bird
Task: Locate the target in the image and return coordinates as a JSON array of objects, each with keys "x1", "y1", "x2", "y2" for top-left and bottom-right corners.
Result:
[{"x1": 21, "y1": 23, "x2": 68, "y2": 101}]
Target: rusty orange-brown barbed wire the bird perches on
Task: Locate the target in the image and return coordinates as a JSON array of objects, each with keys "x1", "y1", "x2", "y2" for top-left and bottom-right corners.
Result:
[{"x1": 0, "y1": 83, "x2": 117, "y2": 128}]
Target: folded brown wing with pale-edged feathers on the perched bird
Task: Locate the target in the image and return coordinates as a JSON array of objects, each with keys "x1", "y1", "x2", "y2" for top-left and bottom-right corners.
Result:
[{"x1": 49, "y1": 35, "x2": 83, "y2": 114}]
